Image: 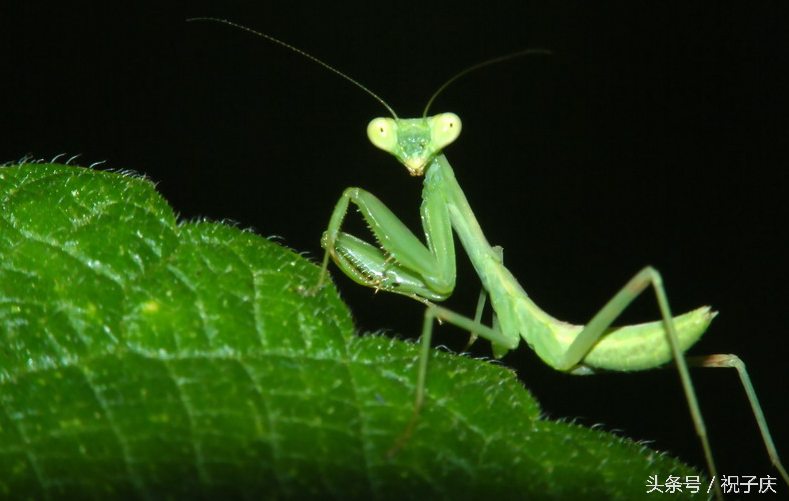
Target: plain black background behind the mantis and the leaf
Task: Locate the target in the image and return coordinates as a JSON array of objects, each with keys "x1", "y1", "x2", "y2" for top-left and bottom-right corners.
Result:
[{"x1": 0, "y1": 1, "x2": 789, "y2": 492}]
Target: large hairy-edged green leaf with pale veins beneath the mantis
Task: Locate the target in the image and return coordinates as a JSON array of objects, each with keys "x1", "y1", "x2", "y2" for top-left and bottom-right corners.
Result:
[{"x1": 0, "y1": 164, "x2": 705, "y2": 501}]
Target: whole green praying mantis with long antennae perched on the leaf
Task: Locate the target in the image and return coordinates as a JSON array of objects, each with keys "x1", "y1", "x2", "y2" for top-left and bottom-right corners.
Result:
[{"x1": 189, "y1": 18, "x2": 789, "y2": 499}]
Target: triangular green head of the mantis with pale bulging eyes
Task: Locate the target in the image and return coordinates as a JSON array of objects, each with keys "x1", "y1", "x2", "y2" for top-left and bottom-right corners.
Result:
[{"x1": 367, "y1": 113, "x2": 461, "y2": 176}]
